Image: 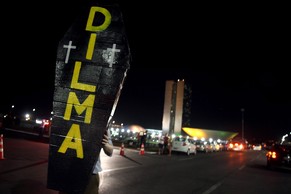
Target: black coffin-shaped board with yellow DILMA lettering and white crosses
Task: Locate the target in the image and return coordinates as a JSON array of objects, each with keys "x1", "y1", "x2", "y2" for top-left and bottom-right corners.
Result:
[{"x1": 47, "y1": 1, "x2": 131, "y2": 194}]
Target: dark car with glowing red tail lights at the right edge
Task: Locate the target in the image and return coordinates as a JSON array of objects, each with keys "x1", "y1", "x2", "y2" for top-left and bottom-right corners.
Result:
[{"x1": 266, "y1": 142, "x2": 291, "y2": 170}]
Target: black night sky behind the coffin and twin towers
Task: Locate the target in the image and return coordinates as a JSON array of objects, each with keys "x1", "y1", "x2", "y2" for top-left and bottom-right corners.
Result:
[{"x1": 0, "y1": 0, "x2": 291, "y2": 141}]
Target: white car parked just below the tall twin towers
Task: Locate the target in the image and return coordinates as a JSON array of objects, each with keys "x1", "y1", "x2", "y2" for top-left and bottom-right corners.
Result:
[{"x1": 172, "y1": 136, "x2": 197, "y2": 155}]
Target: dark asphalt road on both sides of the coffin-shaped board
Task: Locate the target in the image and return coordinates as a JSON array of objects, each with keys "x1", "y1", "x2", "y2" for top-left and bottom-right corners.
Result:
[{"x1": 0, "y1": 129, "x2": 291, "y2": 194}]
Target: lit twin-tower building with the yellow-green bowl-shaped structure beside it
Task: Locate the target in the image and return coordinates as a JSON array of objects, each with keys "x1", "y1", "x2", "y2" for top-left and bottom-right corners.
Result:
[{"x1": 162, "y1": 80, "x2": 239, "y2": 140}]
